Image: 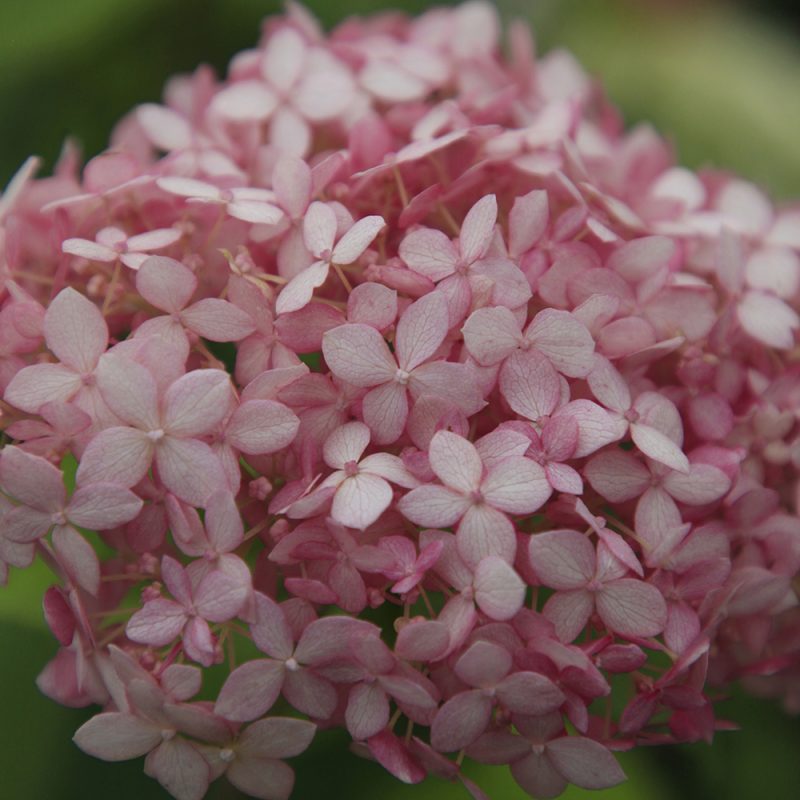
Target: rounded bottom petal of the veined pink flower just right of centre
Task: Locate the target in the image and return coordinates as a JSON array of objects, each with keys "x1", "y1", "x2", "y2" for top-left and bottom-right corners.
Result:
[{"x1": 500, "y1": 350, "x2": 561, "y2": 421}]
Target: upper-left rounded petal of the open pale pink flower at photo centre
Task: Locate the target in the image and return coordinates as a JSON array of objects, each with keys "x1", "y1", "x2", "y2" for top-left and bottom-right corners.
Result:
[{"x1": 322, "y1": 324, "x2": 397, "y2": 387}]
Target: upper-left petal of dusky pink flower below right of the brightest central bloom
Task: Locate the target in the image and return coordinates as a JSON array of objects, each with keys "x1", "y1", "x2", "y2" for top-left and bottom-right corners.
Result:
[{"x1": 528, "y1": 530, "x2": 596, "y2": 589}]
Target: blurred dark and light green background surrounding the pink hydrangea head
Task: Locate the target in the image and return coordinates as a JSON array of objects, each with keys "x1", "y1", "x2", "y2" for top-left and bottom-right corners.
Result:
[{"x1": 0, "y1": 0, "x2": 800, "y2": 800}]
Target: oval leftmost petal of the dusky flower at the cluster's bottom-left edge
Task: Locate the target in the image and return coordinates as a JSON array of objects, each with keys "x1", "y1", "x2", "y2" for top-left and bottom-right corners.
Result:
[{"x1": 74, "y1": 711, "x2": 162, "y2": 761}]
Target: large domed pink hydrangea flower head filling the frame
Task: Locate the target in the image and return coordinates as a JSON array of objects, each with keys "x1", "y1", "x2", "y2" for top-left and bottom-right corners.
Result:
[{"x1": 0, "y1": 1, "x2": 800, "y2": 800}]
